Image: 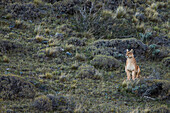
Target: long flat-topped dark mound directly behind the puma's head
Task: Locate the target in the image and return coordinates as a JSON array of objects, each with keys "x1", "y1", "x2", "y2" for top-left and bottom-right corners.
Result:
[{"x1": 93, "y1": 38, "x2": 148, "y2": 59}]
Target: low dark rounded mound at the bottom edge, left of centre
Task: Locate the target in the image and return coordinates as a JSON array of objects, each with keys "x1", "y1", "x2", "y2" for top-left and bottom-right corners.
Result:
[{"x1": 33, "y1": 94, "x2": 74, "y2": 112}]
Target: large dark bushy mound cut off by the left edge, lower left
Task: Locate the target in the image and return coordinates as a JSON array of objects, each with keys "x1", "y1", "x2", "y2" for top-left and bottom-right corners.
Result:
[{"x1": 0, "y1": 75, "x2": 35, "y2": 99}]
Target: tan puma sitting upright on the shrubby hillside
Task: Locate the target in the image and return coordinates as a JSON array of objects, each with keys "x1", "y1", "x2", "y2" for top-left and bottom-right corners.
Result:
[{"x1": 125, "y1": 49, "x2": 140, "y2": 80}]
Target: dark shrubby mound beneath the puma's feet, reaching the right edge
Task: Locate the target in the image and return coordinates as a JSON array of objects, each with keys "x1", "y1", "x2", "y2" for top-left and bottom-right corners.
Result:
[{"x1": 120, "y1": 78, "x2": 170, "y2": 100}]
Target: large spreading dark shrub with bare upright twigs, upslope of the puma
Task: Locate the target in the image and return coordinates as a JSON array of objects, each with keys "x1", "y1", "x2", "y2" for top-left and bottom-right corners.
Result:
[{"x1": 71, "y1": 1, "x2": 136, "y2": 39}]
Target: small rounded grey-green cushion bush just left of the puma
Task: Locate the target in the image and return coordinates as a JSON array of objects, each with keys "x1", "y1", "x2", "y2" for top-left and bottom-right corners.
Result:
[{"x1": 91, "y1": 55, "x2": 120, "y2": 70}]
